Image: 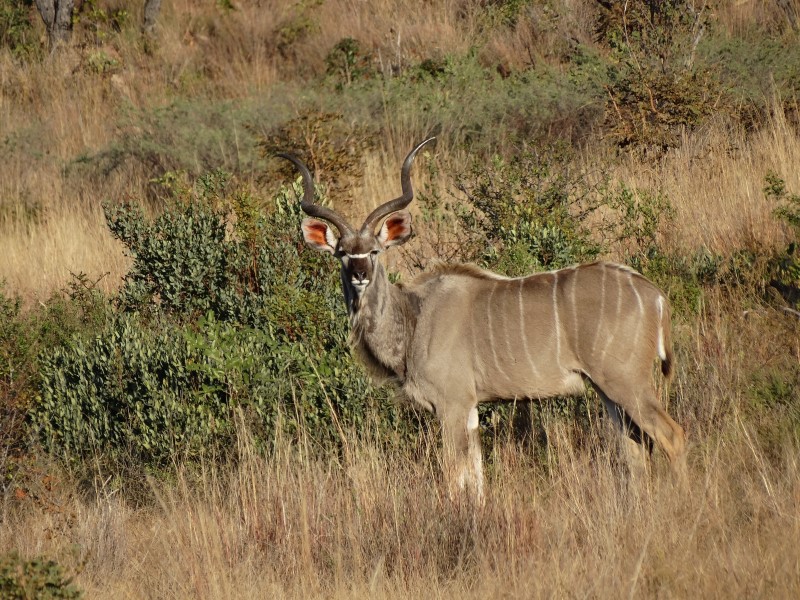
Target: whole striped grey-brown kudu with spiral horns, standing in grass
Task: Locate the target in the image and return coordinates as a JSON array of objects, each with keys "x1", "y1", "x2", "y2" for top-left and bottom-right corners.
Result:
[{"x1": 279, "y1": 138, "x2": 684, "y2": 501}]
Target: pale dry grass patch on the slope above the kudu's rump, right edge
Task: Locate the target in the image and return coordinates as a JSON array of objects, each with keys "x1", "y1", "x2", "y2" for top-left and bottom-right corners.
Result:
[{"x1": 614, "y1": 103, "x2": 800, "y2": 255}]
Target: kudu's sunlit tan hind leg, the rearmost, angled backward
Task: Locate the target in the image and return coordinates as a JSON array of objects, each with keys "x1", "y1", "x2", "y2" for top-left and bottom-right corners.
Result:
[{"x1": 592, "y1": 379, "x2": 686, "y2": 477}]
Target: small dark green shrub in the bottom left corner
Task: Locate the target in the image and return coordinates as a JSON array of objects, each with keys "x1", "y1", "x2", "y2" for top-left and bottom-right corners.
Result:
[{"x1": 0, "y1": 550, "x2": 83, "y2": 600}]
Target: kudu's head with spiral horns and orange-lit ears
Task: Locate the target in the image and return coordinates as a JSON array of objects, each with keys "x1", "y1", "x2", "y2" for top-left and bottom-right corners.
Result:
[{"x1": 278, "y1": 138, "x2": 435, "y2": 300}]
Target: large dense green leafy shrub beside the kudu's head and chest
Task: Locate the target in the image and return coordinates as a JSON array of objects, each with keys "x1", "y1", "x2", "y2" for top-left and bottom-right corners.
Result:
[{"x1": 31, "y1": 173, "x2": 414, "y2": 467}]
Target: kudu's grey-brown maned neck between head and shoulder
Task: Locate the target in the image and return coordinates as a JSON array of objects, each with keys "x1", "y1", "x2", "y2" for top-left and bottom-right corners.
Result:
[{"x1": 342, "y1": 263, "x2": 416, "y2": 382}]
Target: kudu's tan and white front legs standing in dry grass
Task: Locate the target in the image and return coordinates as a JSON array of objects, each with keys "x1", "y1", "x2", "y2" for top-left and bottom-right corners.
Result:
[{"x1": 442, "y1": 407, "x2": 484, "y2": 506}]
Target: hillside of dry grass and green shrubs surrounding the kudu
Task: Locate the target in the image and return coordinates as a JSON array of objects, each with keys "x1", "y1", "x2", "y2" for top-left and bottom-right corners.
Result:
[{"x1": 0, "y1": 0, "x2": 800, "y2": 598}]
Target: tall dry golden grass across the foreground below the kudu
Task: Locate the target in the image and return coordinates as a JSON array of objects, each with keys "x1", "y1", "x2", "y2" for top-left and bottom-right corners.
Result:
[{"x1": 0, "y1": 420, "x2": 800, "y2": 598}]
